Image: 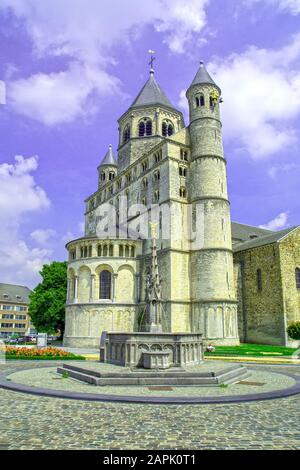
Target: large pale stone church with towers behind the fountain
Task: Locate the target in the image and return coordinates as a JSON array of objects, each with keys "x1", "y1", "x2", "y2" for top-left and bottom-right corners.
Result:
[{"x1": 64, "y1": 62, "x2": 300, "y2": 347}]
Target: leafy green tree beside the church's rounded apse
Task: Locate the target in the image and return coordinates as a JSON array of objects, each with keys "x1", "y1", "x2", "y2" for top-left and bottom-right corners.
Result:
[{"x1": 29, "y1": 261, "x2": 67, "y2": 338}]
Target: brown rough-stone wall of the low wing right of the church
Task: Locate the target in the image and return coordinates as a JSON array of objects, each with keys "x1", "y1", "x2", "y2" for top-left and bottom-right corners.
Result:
[{"x1": 234, "y1": 227, "x2": 300, "y2": 345}]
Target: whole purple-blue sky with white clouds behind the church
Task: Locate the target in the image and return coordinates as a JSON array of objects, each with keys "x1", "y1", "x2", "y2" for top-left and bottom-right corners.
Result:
[{"x1": 0, "y1": 0, "x2": 300, "y2": 287}]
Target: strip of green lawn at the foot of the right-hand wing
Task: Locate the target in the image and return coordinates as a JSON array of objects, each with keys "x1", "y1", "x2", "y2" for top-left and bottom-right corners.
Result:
[{"x1": 205, "y1": 343, "x2": 297, "y2": 357}]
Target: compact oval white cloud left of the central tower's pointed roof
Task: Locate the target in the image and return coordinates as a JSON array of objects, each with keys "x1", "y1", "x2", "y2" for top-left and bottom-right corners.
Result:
[{"x1": 7, "y1": 62, "x2": 120, "y2": 126}]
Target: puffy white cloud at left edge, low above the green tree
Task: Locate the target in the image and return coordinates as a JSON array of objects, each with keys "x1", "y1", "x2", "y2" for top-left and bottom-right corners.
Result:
[{"x1": 0, "y1": 156, "x2": 52, "y2": 285}]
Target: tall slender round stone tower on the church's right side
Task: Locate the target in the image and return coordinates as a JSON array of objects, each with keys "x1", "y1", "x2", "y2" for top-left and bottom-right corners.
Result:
[{"x1": 186, "y1": 62, "x2": 239, "y2": 344}]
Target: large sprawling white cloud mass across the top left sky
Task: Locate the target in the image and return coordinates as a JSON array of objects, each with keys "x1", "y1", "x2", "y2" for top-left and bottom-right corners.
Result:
[{"x1": 0, "y1": 0, "x2": 210, "y2": 126}]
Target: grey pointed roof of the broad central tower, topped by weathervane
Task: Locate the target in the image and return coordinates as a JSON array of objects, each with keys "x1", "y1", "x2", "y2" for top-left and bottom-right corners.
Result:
[{"x1": 130, "y1": 69, "x2": 176, "y2": 109}]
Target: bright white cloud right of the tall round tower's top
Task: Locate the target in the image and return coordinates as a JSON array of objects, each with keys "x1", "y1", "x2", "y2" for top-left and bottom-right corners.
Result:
[{"x1": 208, "y1": 34, "x2": 300, "y2": 158}]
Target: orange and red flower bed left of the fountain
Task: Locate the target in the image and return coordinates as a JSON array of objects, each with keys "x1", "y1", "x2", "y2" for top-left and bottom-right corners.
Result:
[{"x1": 5, "y1": 346, "x2": 85, "y2": 360}]
